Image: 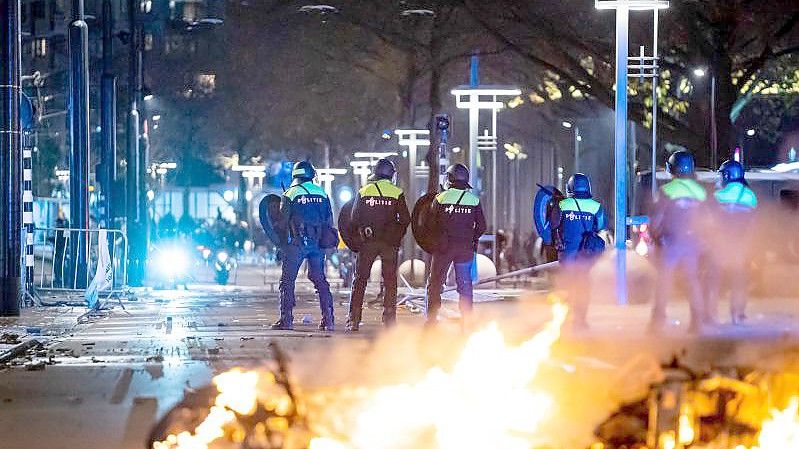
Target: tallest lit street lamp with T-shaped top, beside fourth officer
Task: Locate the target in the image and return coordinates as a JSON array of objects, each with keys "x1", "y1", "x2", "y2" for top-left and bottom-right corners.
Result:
[{"x1": 594, "y1": 0, "x2": 669, "y2": 304}]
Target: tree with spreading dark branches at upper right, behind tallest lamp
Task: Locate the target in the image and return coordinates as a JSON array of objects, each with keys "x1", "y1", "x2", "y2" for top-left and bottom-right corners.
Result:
[{"x1": 462, "y1": 0, "x2": 799, "y2": 163}]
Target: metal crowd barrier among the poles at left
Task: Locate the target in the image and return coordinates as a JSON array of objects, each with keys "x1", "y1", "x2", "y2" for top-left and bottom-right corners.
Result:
[{"x1": 28, "y1": 228, "x2": 128, "y2": 295}]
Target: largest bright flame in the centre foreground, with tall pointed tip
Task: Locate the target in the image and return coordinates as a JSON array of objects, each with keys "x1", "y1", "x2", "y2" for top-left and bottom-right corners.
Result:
[{"x1": 310, "y1": 303, "x2": 568, "y2": 449}]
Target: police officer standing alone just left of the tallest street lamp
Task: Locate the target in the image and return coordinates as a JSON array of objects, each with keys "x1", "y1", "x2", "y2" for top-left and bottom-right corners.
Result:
[{"x1": 550, "y1": 173, "x2": 607, "y2": 328}]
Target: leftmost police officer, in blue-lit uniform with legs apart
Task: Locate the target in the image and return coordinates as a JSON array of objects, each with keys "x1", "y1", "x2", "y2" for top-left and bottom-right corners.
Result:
[{"x1": 272, "y1": 161, "x2": 338, "y2": 331}]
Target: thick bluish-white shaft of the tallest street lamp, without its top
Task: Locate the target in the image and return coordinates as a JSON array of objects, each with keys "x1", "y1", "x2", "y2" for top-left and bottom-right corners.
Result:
[{"x1": 614, "y1": 2, "x2": 630, "y2": 304}]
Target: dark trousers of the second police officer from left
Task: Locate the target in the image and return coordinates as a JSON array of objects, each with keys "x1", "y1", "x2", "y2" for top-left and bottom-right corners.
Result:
[{"x1": 347, "y1": 242, "x2": 399, "y2": 327}]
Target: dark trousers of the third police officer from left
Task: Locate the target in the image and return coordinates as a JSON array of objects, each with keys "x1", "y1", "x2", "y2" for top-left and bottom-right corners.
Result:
[{"x1": 427, "y1": 252, "x2": 474, "y2": 322}]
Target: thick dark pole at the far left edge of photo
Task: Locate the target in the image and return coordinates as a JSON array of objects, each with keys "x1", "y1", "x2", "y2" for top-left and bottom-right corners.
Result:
[{"x1": 0, "y1": 0, "x2": 22, "y2": 316}]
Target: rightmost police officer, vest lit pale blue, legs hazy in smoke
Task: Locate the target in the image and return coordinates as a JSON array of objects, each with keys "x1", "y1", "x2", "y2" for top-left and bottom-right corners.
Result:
[{"x1": 705, "y1": 160, "x2": 757, "y2": 324}]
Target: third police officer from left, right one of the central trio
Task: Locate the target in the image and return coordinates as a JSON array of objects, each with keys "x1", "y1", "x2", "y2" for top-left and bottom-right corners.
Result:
[{"x1": 427, "y1": 164, "x2": 486, "y2": 326}]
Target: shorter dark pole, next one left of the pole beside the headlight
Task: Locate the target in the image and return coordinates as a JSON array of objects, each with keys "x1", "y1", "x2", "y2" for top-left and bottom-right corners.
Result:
[{"x1": 98, "y1": 0, "x2": 117, "y2": 228}]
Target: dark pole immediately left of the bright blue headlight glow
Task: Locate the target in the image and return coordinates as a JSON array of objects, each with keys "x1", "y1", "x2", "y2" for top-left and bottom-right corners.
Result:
[{"x1": 125, "y1": 0, "x2": 146, "y2": 286}]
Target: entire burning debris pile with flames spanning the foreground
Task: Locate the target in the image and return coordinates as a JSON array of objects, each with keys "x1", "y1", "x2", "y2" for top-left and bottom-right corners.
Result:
[{"x1": 148, "y1": 303, "x2": 799, "y2": 449}]
